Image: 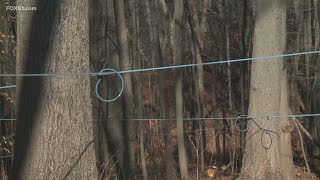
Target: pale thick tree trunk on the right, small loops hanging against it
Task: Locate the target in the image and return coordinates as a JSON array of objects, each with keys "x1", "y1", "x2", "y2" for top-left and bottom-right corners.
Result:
[{"x1": 239, "y1": 0, "x2": 295, "y2": 179}]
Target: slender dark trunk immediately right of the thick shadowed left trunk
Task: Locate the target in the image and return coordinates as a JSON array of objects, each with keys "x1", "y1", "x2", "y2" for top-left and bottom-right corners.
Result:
[{"x1": 89, "y1": 0, "x2": 111, "y2": 179}]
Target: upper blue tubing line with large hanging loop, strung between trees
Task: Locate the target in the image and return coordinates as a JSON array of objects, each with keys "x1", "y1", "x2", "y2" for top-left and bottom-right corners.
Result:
[{"x1": 0, "y1": 51, "x2": 320, "y2": 102}]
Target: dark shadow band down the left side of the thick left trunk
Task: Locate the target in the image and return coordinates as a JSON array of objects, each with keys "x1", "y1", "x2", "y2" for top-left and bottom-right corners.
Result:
[{"x1": 11, "y1": 0, "x2": 60, "y2": 179}]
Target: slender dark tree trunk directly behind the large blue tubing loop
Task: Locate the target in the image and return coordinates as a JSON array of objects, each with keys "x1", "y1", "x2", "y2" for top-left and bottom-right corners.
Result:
[{"x1": 98, "y1": 0, "x2": 129, "y2": 179}]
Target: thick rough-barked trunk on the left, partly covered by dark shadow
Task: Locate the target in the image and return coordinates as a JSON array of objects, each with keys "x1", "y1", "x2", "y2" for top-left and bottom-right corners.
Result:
[{"x1": 11, "y1": 0, "x2": 98, "y2": 179}]
